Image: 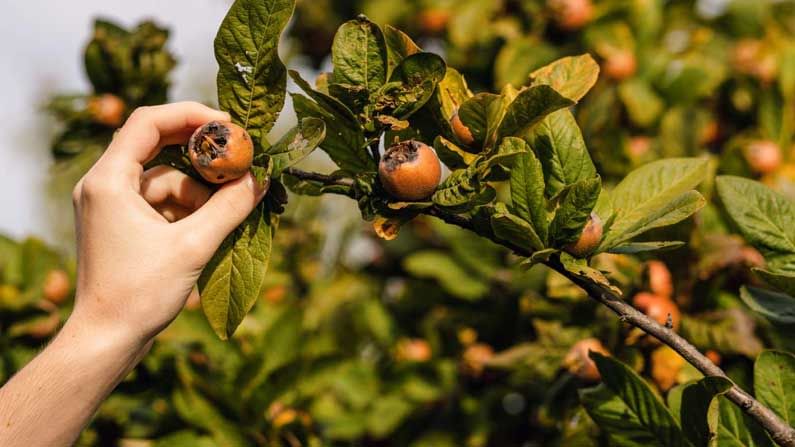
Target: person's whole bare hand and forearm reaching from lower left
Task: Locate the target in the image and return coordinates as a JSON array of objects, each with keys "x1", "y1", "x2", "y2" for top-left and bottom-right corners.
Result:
[{"x1": 0, "y1": 102, "x2": 267, "y2": 447}]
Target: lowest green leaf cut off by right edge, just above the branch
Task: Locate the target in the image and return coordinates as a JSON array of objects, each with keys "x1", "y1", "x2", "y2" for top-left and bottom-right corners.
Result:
[{"x1": 754, "y1": 351, "x2": 795, "y2": 427}]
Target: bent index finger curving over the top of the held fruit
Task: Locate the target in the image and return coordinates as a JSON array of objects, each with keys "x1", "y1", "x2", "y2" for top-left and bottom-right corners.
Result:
[{"x1": 105, "y1": 102, "x2": 229, "y2": 170}]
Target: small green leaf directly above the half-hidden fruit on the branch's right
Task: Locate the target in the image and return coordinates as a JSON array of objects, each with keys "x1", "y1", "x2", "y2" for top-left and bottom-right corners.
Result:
[{"x1": 549, "y1": 176, "x2": 602, "y2": 246}]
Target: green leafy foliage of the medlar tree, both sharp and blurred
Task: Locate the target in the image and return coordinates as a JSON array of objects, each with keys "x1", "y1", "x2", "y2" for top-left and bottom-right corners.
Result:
[{"x1": 14, "y1": 0, "x2": 795, "y2": 446}]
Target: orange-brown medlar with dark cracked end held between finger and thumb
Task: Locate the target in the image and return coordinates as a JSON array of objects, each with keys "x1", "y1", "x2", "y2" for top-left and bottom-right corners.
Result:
[{"x1": 188, "y1": 121, "x2": 254, "y2": 183}]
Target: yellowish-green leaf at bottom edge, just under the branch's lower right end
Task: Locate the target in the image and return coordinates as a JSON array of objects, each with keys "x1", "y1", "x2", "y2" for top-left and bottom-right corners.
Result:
[{"x1": 716, "y1": 396, "x2": 775, "y2": 447}]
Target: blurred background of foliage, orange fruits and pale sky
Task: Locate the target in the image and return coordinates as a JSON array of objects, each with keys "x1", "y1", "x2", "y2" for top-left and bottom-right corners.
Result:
[{"x1": 0, "y1": 0, "x2": 795, "y2": 447}]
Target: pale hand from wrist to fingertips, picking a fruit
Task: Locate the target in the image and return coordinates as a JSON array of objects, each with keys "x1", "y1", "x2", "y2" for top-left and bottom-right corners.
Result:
[{"x1": 70, "y1": 102, "x2": 267, "y2": 346}]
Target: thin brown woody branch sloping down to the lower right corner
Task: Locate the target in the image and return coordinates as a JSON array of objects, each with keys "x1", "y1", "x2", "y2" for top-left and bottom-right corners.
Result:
[{"x1": 285, "y1": 168, "x2": 795, "y2": 447}]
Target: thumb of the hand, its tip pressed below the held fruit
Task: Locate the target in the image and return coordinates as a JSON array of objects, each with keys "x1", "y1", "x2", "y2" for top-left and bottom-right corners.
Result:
[{"x1": 178, "y1": 173, "x2": 270, "y2": 258}]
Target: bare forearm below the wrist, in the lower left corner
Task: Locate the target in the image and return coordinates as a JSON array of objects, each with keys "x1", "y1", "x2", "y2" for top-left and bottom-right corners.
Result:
[{"x1": 0, "y1": 308, "x2": 146, "y2": 446}]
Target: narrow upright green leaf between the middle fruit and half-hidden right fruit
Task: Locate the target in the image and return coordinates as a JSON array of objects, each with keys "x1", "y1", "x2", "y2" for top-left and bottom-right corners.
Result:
[{"x1": 511, "y1": 145, "x2": 549, "y2": 245}]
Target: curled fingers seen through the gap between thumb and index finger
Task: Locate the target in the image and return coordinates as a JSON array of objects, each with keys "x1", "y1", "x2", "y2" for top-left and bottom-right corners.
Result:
[{"x1": 140, "y1": 165, "x2": 212, "y2": 213}]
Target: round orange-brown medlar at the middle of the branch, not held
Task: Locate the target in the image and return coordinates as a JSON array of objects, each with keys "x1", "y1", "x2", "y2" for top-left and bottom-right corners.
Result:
[{"x1": 378, "y1": 140, "x2": 442, "y2": 201}]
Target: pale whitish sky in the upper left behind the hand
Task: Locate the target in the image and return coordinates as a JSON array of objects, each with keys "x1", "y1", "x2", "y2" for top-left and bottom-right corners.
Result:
[{"x1": 0, "y1": 0, "x2": 304, "y2": 242}]
